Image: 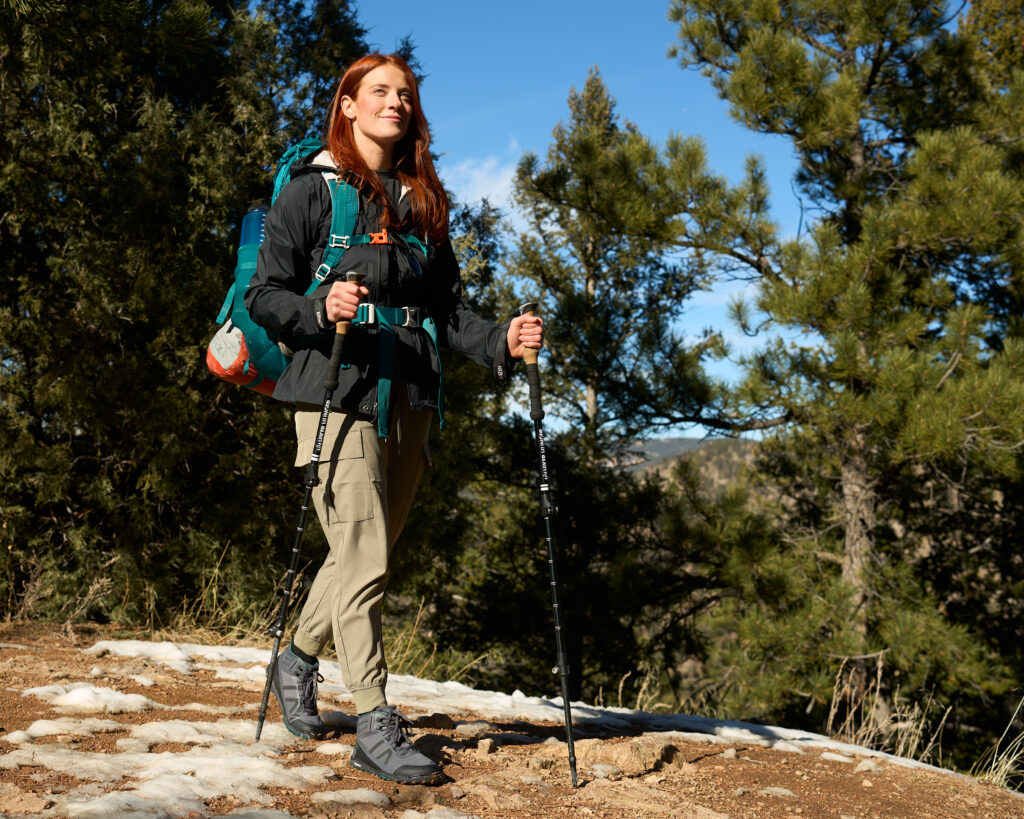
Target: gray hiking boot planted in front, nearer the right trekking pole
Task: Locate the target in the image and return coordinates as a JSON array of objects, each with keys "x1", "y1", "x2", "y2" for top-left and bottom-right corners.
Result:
[{"x1": 350, "y1": 705, "x2": 443, "y2": 785}]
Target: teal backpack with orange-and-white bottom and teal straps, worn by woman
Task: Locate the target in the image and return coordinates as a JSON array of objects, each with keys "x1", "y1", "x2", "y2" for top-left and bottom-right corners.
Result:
[{"x1": 206, "y1": 137, "x2": 443, "y2": 438}]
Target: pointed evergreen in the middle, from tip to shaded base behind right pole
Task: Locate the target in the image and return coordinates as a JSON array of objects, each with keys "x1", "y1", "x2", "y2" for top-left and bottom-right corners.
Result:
[{"x1": 413, "y1": 71, "x2": 753, "y2": 704}]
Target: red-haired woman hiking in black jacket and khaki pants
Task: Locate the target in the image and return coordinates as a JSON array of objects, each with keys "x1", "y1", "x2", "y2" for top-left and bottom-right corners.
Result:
[{"x1": 246, "y1": 54, "x2": 543, "y2": 782}]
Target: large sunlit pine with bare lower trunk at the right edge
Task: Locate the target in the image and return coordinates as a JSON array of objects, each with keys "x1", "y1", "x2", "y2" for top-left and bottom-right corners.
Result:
[{"x1": 670, "y1": 0, "x2": 1024, "y2": 761}]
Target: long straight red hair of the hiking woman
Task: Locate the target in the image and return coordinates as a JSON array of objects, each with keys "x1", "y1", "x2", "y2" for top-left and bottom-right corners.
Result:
[{"x1": 325, "y1": 53, "x2": 449, "y2": 241}]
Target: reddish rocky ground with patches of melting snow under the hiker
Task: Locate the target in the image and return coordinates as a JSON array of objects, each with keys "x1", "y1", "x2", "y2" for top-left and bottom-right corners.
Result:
[{"x1": 0, "y1": 624, "x2": 1024, "y2": 819}]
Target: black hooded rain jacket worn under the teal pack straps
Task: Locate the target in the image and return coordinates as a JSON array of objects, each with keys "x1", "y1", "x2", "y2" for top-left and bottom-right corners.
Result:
[{"x1": 245, "y1": 152, "x2": 512, "y2": 419}]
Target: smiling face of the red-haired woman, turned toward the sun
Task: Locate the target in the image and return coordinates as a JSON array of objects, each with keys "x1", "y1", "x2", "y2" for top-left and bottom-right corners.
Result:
[{"x1": 341, "y1": 63, "x2": 413, "y2": 159}]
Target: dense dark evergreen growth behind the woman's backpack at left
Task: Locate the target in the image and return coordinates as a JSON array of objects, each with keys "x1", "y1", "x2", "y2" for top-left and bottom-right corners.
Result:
[{"x1": 0, "y1": 0, "x2": 366, "y2": 621}]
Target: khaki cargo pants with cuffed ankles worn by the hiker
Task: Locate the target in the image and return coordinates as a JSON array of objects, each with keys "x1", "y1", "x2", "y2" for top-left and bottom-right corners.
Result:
[{"x1": 294, "y1": 387, "x2": 433, "y2": 714}]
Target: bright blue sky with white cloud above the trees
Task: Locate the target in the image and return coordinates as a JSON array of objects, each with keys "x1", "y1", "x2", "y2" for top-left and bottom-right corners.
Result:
[{"x1": 358, "y1": 0, "x2": 799, "y2": 409}]
